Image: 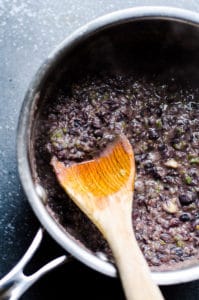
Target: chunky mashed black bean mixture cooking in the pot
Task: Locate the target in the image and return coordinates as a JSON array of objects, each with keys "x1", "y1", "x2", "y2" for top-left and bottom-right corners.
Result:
[{"x1": 37, "y1": 74, "x2": 199, "y2": 268}]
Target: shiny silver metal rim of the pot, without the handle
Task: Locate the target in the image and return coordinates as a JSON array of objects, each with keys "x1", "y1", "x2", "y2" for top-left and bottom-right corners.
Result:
[{"x1": 17, "y1": 6, "x2": 199, "y2": 285}]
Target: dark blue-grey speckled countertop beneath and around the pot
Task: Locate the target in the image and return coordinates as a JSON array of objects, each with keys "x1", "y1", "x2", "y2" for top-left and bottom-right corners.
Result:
[{"x1": 0, "y1": 0, "x2": 199, "y2": 300}]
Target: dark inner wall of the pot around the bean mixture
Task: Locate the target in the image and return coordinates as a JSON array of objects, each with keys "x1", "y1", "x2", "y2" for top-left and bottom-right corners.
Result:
[{"x1": 30, "y1": 18, "x2": 199, "y2": 276}]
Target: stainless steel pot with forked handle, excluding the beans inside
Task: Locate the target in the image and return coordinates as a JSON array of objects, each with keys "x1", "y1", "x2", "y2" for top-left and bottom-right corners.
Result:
[{"x1": 0, "y1": 7, "x2": 199, "y2": 299}]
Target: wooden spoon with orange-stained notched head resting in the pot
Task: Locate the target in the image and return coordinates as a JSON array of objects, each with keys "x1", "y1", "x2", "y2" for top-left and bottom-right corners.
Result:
[{"x1": 51, "y1": 136, "x2": 163, "y2": 300}]
